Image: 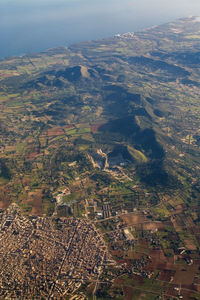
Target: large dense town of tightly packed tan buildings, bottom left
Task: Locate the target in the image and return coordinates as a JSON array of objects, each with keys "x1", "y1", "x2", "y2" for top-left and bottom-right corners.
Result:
[{"x1": 0, "y1": 205, "x2": 109, "y2": 299}]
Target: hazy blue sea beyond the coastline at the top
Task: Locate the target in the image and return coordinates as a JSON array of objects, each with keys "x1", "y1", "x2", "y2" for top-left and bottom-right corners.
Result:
[{"x1": 0, "y1": 0, "x2": 200, "y2": 57}]
